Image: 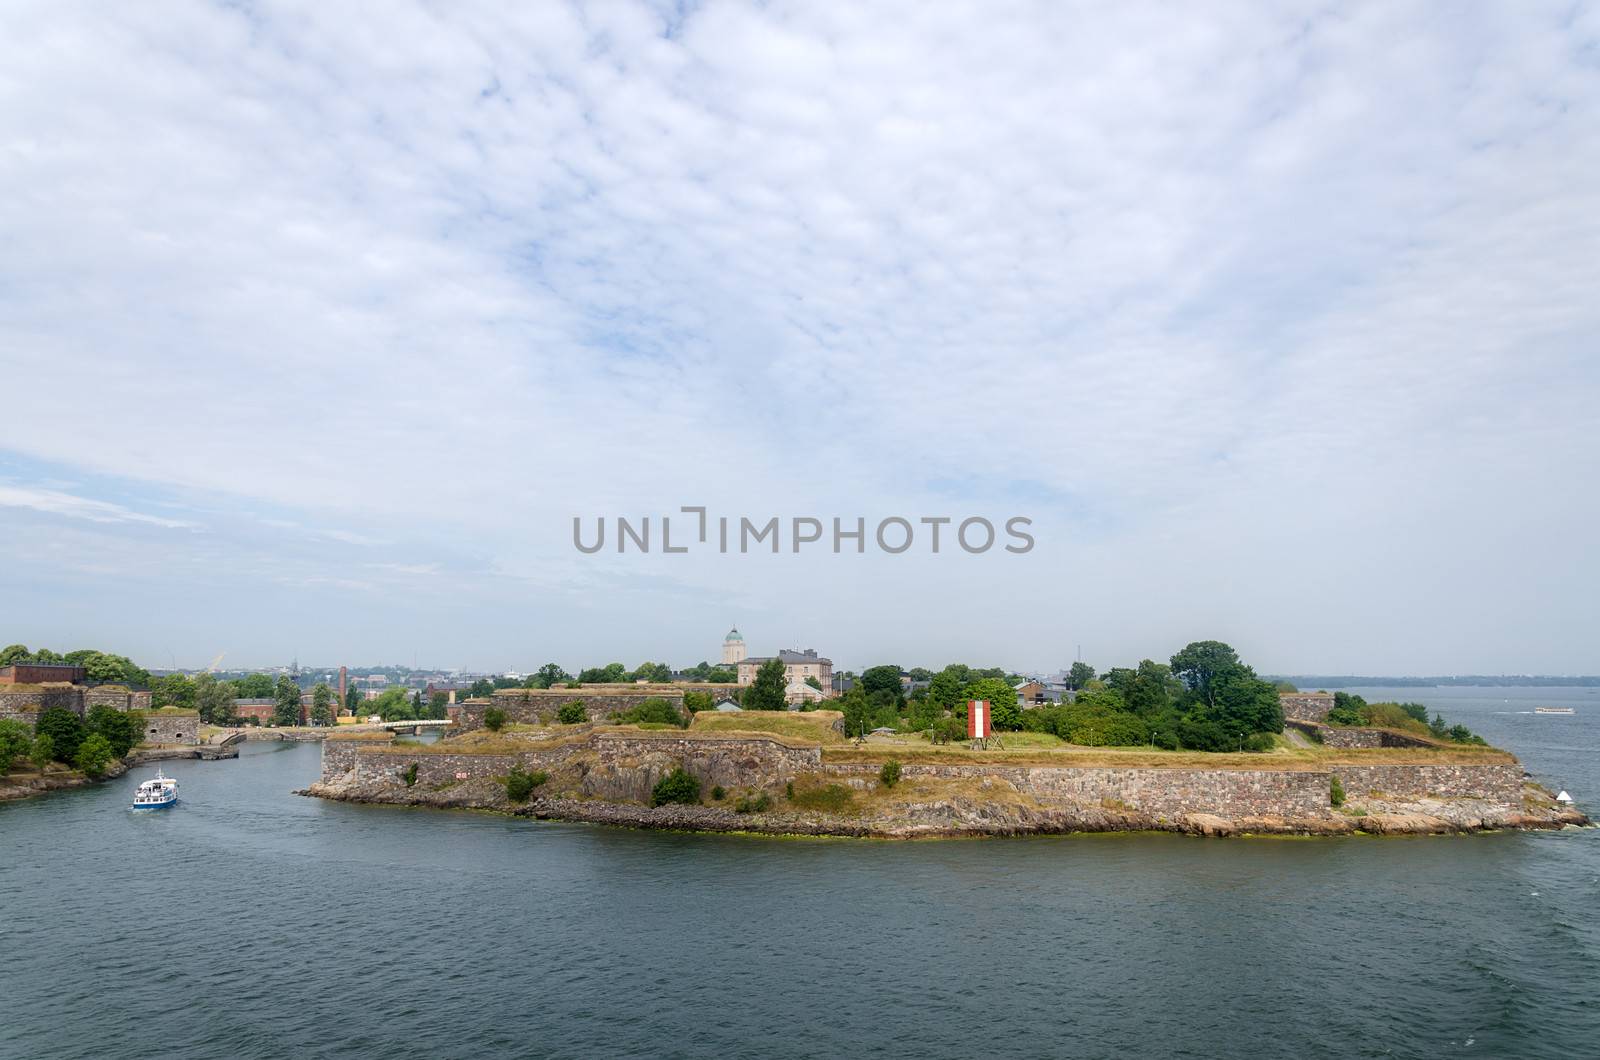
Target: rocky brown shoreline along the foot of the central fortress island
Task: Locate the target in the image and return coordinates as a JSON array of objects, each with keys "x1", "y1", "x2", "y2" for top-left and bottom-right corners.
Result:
[{"x1": 296, "y1": 778, "x2": 1589, "y2": 839}]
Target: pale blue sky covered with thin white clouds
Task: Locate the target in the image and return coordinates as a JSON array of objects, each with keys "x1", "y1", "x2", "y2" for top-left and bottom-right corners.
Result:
[{"x1": 0, "y1": 0, "x2": 1600, "y2": 674}]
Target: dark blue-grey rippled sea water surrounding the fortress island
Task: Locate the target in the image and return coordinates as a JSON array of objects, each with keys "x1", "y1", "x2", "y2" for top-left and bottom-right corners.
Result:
[{"x1": 0, "y1": 689, "x2": 1600, "y2": 1060}]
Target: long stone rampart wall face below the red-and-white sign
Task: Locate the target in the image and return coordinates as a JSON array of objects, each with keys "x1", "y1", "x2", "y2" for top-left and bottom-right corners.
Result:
[{"x1": 826, "y1": 762, "x2": 1331, "y2": 817}]
